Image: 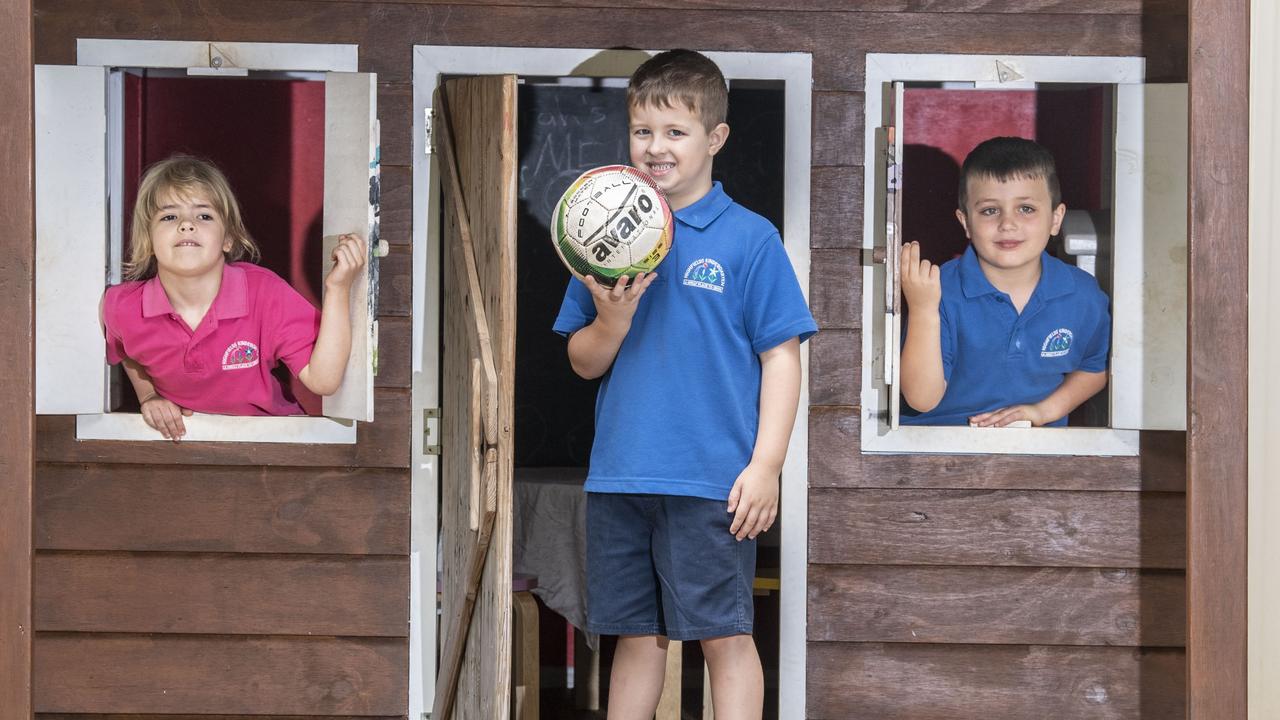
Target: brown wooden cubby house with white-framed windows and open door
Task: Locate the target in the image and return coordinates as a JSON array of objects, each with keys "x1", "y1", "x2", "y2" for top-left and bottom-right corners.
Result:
[{"x1": 0, "y1": 0, "x2": 1248, "y2": 720}]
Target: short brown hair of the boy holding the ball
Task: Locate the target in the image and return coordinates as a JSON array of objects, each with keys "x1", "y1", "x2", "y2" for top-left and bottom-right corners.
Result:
[{"x1": 627, "y1": 50, "x2": 728, "y2": 132}]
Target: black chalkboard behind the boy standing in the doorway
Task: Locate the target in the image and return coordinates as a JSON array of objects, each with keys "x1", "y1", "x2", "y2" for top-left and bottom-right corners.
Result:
[{"x1": 515, "y1": 82, "x2": 786, "y2": 466}]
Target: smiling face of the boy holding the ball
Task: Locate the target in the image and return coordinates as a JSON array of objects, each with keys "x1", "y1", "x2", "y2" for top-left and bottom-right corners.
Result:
[{"x1": 628, "y1": 102, "x2": 728, "y2": 210}]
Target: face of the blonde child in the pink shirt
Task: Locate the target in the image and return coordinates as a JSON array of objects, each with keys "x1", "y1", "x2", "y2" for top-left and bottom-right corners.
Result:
[{"x1": 150, "y1": 191, "x2": 232, "y2": 278}]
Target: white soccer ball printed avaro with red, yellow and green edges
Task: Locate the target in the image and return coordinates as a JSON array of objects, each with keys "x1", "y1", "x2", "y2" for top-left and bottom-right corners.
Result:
[{"x1": 552, "y1": 165, "x2": 673, "y2": 287}]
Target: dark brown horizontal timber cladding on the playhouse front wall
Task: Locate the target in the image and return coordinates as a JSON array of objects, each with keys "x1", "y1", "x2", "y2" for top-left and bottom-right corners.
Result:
[{"x1": 33, "y1": 0, "x2": 1188, "y2": 720}]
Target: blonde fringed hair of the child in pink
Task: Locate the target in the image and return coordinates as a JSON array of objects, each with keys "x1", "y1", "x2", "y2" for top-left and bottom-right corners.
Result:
[{"x1": 124, "y1": 155, "x2": 260, "y2": 281}]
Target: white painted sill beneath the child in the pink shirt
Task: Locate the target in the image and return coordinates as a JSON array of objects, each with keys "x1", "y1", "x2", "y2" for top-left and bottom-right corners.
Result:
[{"x1": 76, "y1": 413, "x2": 356, "y2": 445}]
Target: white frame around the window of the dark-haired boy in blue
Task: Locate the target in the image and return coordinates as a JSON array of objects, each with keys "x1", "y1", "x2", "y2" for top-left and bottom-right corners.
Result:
[{"x1": 861, "y1": 53, "x2": 1185, "y2": 456}]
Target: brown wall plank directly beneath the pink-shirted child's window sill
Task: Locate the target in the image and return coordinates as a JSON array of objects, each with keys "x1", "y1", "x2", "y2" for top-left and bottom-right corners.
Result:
[{"x1": 36, "y1": 386, "x2": 410, "y2": 468}]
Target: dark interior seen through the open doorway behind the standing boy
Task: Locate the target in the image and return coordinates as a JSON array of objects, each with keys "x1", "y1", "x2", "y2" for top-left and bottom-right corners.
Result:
[{"x1": 512, "y1": 77, "x2": 785, "y2": 717}]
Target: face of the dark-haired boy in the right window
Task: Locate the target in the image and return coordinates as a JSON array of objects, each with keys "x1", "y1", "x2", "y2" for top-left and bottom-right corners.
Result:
[{"x1": 956, "y1": 176, "x2": 1066, "y2": 281}]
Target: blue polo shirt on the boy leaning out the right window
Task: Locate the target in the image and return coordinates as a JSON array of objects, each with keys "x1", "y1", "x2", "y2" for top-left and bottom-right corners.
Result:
[{"x1": 901, "y1": 246, "x2": 1111, "y2": 425}]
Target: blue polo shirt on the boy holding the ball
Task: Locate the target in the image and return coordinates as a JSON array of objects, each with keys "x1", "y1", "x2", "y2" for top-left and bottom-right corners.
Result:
[{"x1": 554, "y1": 182, "x2": 818, "y2": 500}]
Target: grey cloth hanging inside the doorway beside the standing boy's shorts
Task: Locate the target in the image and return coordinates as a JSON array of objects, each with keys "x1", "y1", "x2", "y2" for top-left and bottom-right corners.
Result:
[{"x1": 512, "y1": 468, "x2": 599, "y2": 651}]
